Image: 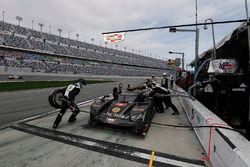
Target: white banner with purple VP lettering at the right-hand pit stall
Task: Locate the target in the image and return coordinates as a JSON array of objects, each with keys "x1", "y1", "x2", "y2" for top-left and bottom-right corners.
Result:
[{"x1": 208, "y1": 59, "x2": 238, "y2": 73}]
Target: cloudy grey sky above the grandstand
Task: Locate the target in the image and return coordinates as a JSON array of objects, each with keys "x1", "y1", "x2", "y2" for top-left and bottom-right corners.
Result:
[{"x1": 0, "y1": 0, "x2": 250, "y2": 68}]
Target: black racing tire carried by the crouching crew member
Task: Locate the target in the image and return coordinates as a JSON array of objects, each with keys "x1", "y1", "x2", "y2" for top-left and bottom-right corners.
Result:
[{"x1": 48, "y1": 89, "x2": 63, "y2": 108}]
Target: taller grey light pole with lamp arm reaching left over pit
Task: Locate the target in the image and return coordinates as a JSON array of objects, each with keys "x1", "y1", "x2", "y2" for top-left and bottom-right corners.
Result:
[{"x1": 169, "y1": 27, "x2": 199, "y2": 72}]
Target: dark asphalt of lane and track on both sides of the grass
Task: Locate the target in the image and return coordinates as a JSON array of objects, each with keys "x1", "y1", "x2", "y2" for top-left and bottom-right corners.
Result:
[{"x1": 0, "y1": 75, "x2": 144, "y2": 126}]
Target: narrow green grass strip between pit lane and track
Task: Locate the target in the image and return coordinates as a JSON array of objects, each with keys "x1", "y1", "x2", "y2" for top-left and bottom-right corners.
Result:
[{"x1": 0, "y1": 80, "x2": 113, "y2": 92}]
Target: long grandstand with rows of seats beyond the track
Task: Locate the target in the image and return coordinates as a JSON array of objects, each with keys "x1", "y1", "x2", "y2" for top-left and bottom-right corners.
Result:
[{"x1": 0, "y1": 21, "x2": 168, "y2": 76}]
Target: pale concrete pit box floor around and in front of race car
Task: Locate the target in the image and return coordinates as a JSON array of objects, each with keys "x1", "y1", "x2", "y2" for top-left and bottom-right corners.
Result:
[{"x1": 0, "y1": 98, "x2": 210, "y2": 166}]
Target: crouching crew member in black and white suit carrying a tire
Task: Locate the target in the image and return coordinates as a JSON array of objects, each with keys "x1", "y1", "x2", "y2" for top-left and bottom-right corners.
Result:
[{"x1": 53, "y1": 79, "x2": 86, "y2": 128}]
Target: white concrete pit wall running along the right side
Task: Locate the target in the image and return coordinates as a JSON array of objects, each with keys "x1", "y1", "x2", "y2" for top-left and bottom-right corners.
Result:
[{"x1": 177, "y1": 88, "x2": 250, "y2": 167}]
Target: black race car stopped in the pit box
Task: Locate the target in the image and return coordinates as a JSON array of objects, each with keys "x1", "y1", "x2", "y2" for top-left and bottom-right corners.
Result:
[{"x1": 90, "y1": 90, "x2": 156, "y2": 135}]
